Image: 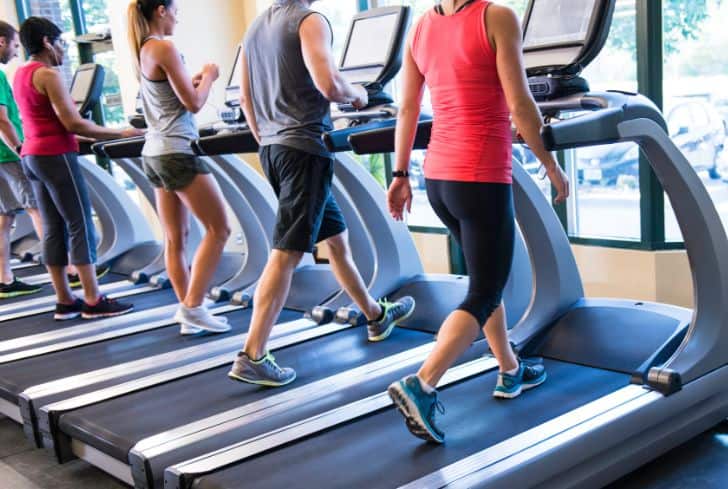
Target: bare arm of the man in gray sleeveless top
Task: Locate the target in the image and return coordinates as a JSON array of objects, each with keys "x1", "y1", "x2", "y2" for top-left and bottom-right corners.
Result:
[{"x1": 299, "y1": 14, "x2": 367, "y2": 107}]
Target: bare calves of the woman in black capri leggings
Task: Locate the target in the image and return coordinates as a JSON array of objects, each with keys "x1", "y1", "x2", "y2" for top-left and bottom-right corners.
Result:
[{"x1": 417, "y1": 304, "x2": 518, "y2": 387}]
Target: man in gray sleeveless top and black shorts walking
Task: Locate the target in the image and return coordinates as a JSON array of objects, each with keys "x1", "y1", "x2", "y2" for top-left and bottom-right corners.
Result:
[{"x1": 228, "y1": 0, "x2": 414, "y2": 386}]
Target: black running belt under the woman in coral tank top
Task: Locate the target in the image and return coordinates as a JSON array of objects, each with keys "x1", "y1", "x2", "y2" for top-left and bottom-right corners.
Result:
[{"x1": 193, "y1": 360, "x2": 629, "y2": 489}]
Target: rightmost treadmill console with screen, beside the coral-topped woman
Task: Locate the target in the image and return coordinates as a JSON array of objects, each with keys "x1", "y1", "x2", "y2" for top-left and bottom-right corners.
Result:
[{"x1": 523, "y1": 0, "x2": 615, "y2": 101}]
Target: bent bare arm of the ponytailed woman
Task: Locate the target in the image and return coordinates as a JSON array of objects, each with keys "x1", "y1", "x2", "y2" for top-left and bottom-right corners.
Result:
[{"x1": 154, "y1": 41, "x2": 219, "y2": 114}]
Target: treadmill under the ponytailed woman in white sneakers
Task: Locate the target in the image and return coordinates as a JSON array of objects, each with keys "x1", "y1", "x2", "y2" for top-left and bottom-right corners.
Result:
[{"x1": 0, "y1": 60, "x2": 290, "y2": 430}]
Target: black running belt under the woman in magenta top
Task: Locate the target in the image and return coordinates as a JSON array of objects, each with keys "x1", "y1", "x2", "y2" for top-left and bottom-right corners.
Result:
[{"x1": 0, "y1": 289, "x2": 177, "y2": 341}]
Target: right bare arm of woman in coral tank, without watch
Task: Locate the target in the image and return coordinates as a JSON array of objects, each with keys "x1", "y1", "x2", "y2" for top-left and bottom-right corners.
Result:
[{"x1": 486, "y1": 5, "x2": 569, "y2": 203}]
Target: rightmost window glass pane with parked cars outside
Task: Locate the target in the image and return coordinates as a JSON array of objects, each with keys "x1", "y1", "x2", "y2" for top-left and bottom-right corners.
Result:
[{"x1": 663, "y1": 0, "x2": 728, "y2": 241}]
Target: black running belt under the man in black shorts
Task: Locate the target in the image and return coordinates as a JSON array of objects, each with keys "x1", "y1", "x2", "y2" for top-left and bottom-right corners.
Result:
[{"x1": 60, "y1": 328, "x2": 432, "y2": 462}]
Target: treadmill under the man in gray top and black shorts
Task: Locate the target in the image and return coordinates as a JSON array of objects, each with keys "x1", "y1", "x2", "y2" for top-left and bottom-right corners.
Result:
[{"x1": 25, "y1": 7, "x2": 531, "y2": 487}]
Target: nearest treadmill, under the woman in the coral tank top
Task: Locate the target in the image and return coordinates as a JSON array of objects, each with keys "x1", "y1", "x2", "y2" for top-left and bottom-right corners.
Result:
[{"x1": 165, "y1": 0, "x2": 728, "y2": 489}]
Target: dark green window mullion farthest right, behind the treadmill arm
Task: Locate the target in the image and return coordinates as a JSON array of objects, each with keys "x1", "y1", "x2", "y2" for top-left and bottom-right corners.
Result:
[{"x1": 635, "y1": 0, "x2": 665, "y2": 250}]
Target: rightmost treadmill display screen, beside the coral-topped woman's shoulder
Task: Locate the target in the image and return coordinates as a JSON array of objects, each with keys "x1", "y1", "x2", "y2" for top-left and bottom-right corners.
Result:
[{"x1": 523, "y1": 0, "x2": 596, "y2": 48}]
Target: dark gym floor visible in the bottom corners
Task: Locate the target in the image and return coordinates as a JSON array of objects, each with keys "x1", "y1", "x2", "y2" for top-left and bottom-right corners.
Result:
[{"x1": 0, "y1": 416, "x2": 728, "y2": 489}]
